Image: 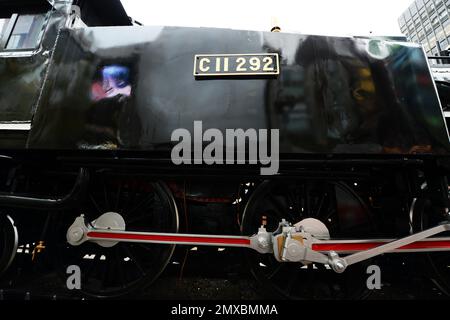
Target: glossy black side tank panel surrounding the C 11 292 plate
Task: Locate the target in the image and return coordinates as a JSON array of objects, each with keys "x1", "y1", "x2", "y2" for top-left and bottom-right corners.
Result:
[{"x1": 19, "y1": 27, "x2": 449, "y2": 154}]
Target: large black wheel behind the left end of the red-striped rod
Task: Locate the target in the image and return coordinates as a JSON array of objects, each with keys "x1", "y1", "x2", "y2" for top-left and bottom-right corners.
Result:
[{"x1": 54, "y1": 177, "x2": 178, "y2": 298}]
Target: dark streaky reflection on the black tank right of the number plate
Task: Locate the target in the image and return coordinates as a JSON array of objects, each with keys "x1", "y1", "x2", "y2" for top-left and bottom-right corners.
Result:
[{"x1": 267, "y1": 36, "x2": 445, "y2": 154}]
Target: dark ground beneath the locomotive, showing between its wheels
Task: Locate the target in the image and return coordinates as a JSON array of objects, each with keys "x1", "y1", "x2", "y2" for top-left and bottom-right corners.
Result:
[{"x1": 0, "y1": 247, "x2": 448, "y2": 300}]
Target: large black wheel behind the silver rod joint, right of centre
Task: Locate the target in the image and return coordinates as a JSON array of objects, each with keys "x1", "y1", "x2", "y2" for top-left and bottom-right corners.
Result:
[{"x1": 241, "y1": 182, "x2": 374, "y2": 299}]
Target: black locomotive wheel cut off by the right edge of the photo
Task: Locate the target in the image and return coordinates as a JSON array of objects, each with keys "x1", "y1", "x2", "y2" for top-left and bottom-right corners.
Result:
[{"x1": 413, "y1": 199, "x2": 450, "y2": 296}]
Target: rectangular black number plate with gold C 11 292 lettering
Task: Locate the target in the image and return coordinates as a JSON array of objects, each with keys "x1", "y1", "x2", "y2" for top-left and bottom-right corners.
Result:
[{"x1": 194, "y1": 53, "x2": 280, "y2": 77}]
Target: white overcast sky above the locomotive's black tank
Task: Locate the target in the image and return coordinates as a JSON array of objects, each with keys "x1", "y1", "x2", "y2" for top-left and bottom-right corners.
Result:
[{"x1": 122, "y1": 0, "x2": 413, "y2": 36}]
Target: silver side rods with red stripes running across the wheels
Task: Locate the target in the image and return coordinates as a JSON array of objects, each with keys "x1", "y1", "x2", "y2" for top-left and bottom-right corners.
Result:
[{"x1": 67, "y1": 213, "x2": 450, "y2": 273}]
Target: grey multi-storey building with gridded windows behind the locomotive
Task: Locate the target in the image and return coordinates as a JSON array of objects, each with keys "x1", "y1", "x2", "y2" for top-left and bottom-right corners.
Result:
[{"x1": 398, "y1": 0, "x2": 450, "y2": 55}]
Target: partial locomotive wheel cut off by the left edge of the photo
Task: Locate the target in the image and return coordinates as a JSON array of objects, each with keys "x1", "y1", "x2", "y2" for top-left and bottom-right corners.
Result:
[{"x1": 0, "y1": 214, "x2": 19, "y2": 276}]
